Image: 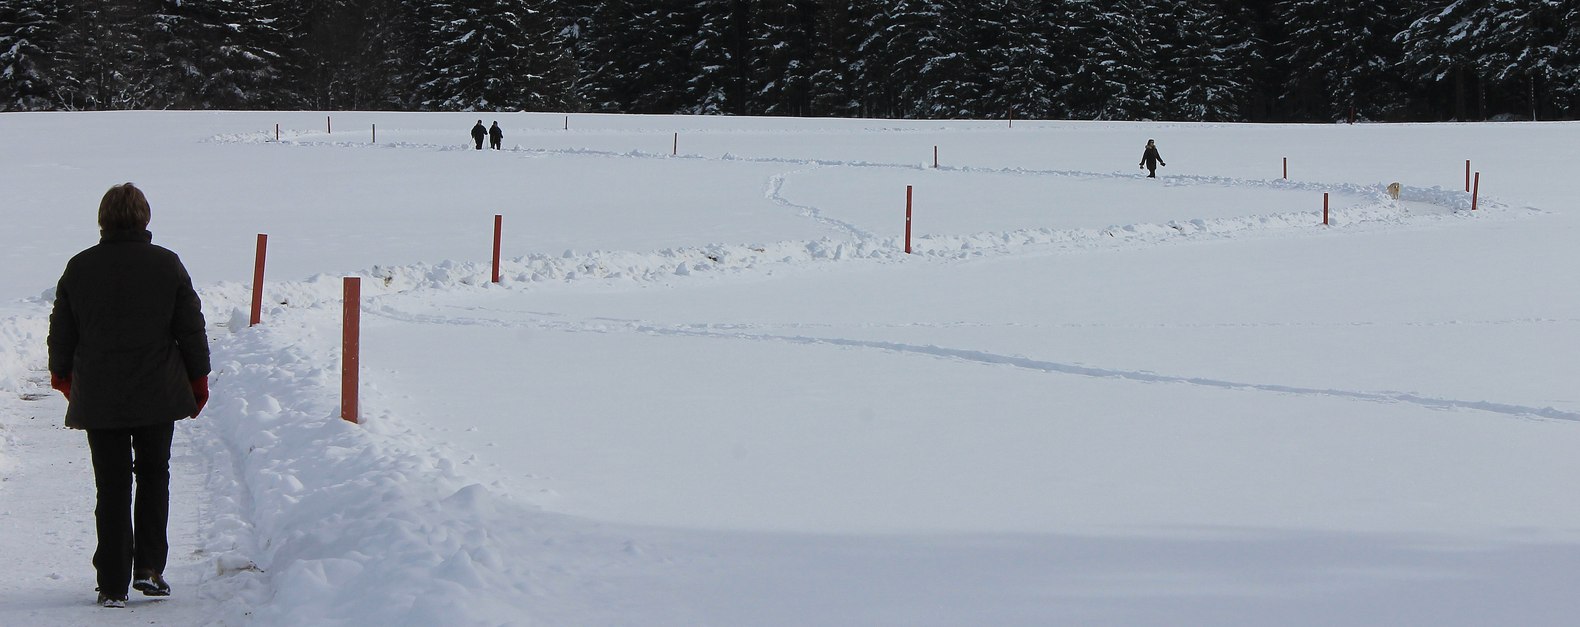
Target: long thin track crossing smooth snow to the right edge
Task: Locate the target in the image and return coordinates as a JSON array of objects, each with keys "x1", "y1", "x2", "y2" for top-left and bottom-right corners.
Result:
[{"x1": 361, "y1": 305, "x2": 1580, "y2": 422}]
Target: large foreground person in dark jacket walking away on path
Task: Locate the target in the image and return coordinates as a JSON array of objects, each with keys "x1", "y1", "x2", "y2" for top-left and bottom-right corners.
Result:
[{"x1": 47, "y1": 183, "x2": 209, "y2": 608}]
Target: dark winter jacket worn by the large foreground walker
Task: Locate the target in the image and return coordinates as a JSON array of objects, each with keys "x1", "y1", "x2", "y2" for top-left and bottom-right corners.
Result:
[{"x1": 49, "y1": 229, "x2": 209, "y2": 430}]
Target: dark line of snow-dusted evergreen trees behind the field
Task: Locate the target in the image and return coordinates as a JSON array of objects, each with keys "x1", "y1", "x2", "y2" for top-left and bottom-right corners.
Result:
[{"x1": 0, "y1": 0, "x2": 1580, "y2": 122}]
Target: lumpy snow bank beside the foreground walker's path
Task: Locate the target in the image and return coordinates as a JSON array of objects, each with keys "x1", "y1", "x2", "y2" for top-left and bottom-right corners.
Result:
[{"x1": 182, "y1": 320, "x2": 532, "y2": 625}]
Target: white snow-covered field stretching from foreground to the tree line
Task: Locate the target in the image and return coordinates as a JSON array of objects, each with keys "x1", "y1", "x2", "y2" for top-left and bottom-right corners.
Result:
[{"x1": 0, "y1": 112, "x2": 1580, "y2": 625}]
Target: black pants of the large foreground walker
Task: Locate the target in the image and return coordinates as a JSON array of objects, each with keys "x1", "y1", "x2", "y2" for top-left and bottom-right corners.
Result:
[{"x1": 88, "y1": 422, "x2": 175, "y2": 597}]
